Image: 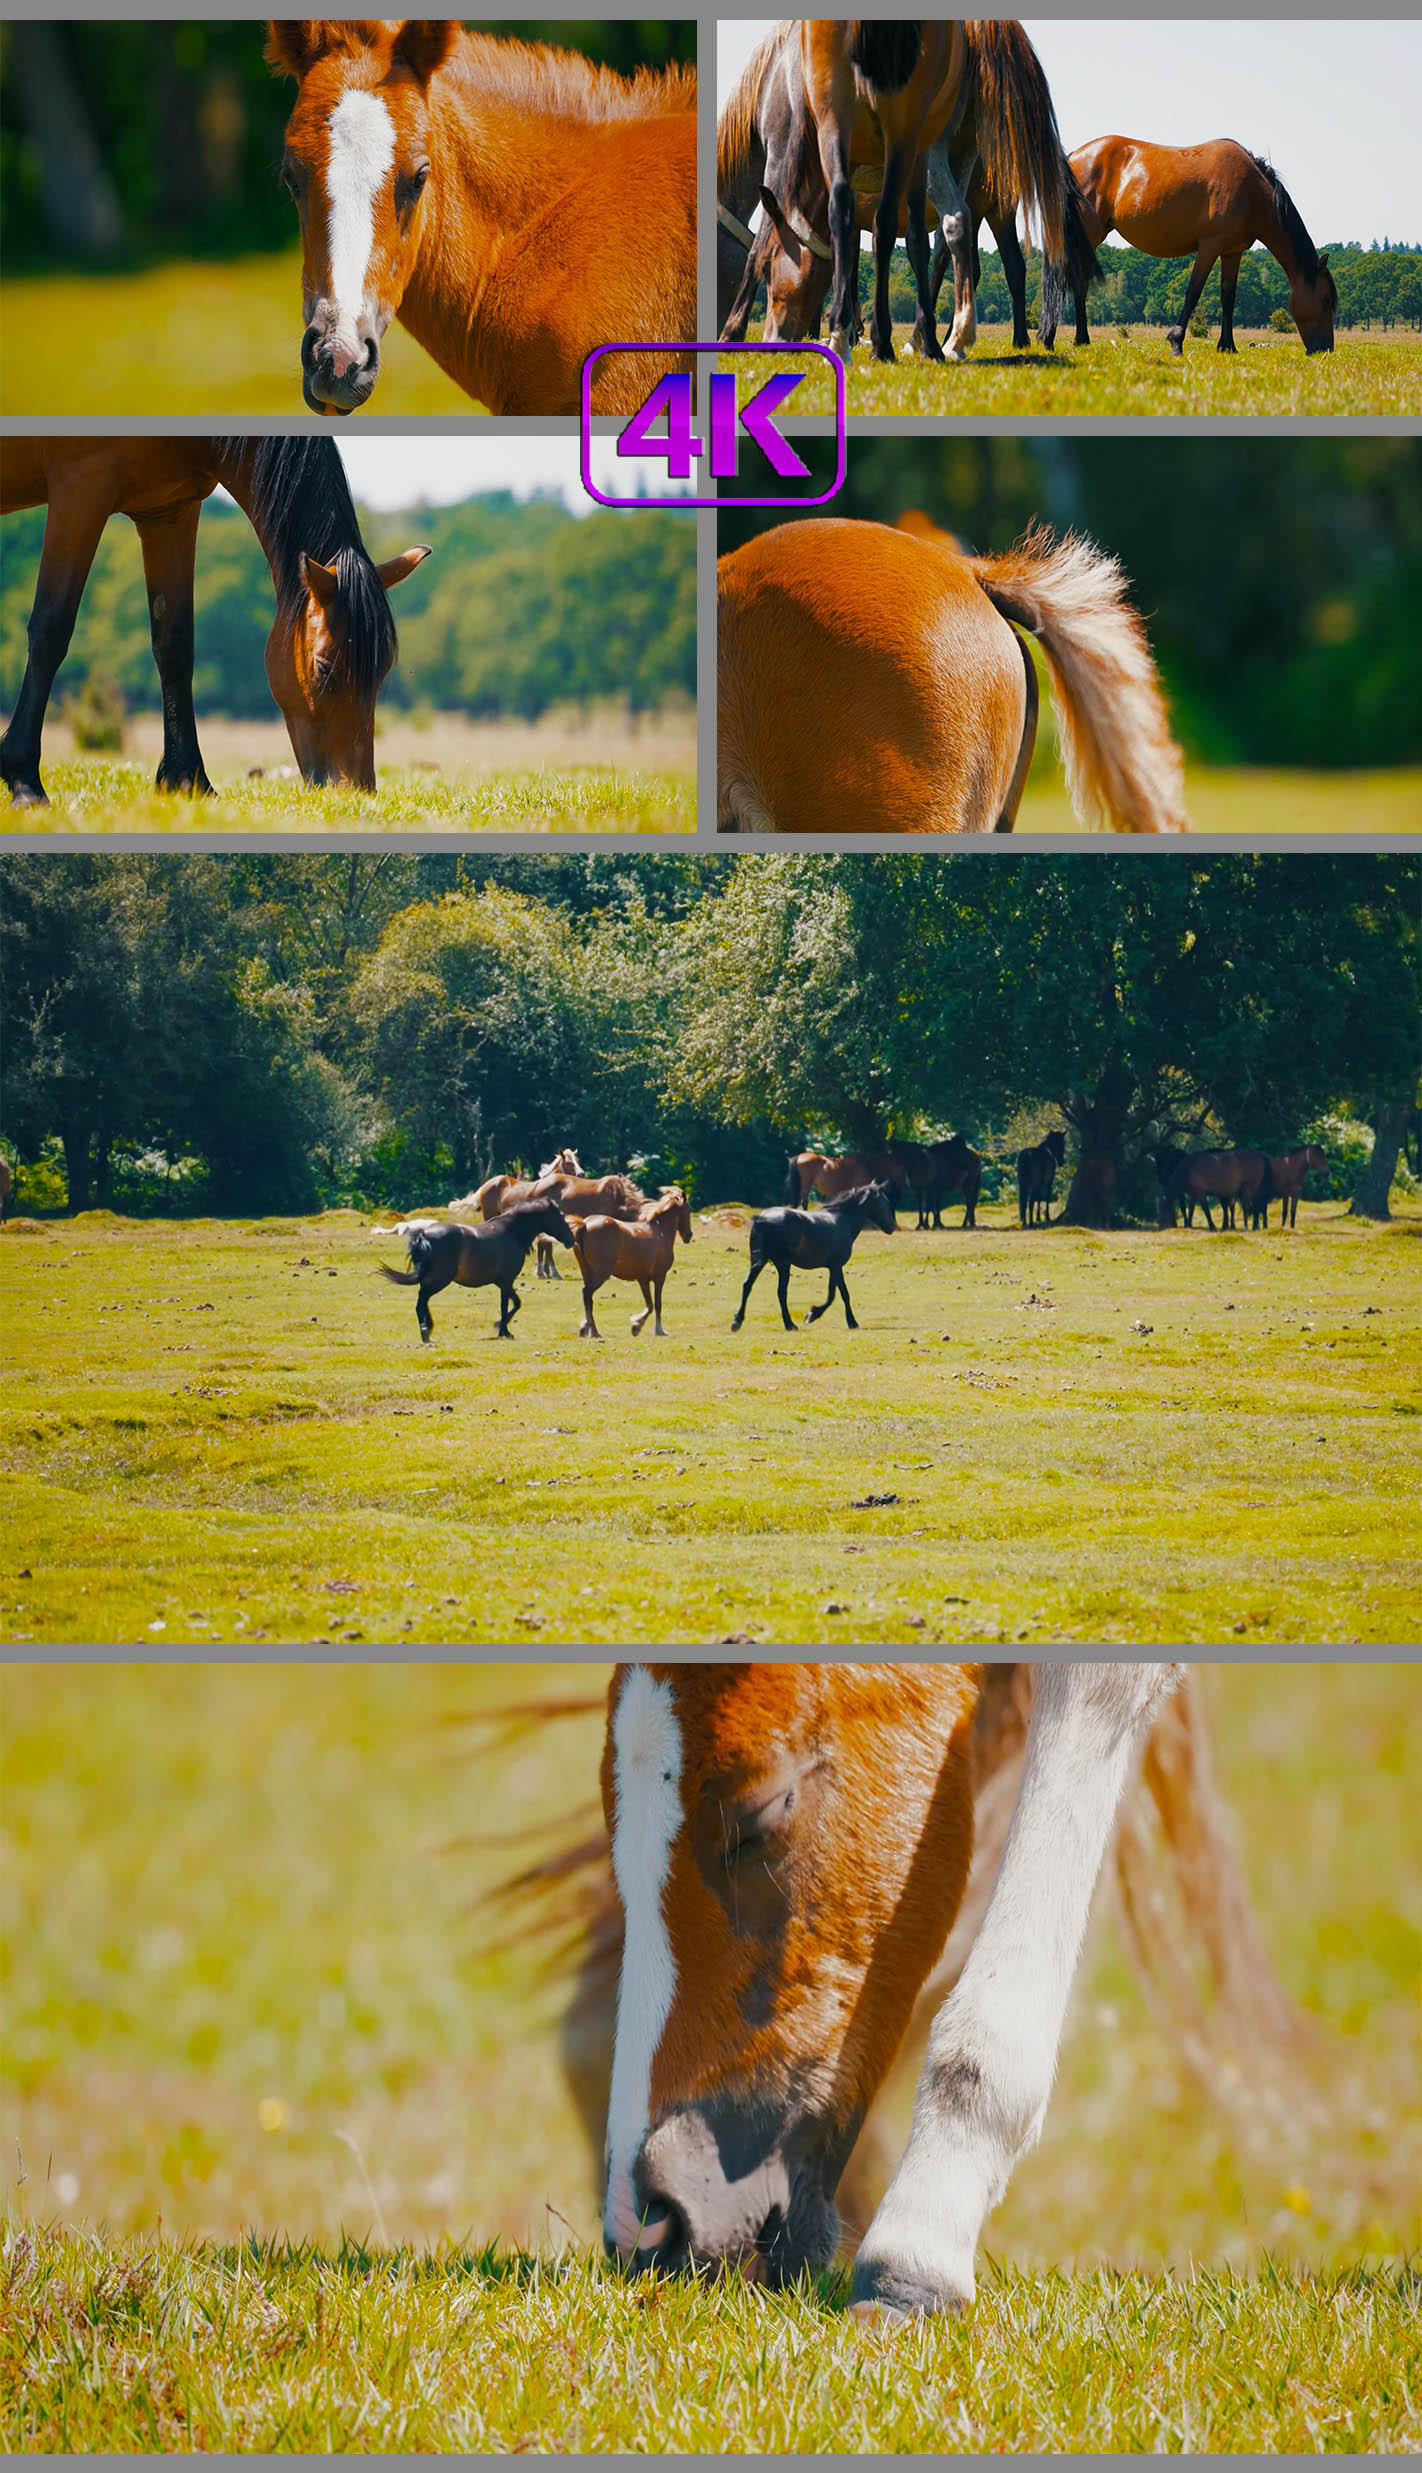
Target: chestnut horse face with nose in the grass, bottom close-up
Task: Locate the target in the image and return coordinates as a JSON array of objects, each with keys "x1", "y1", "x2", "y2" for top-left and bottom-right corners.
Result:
[{"x1": 603, "y1": 1664, "x2": 979, "y2": 2283}]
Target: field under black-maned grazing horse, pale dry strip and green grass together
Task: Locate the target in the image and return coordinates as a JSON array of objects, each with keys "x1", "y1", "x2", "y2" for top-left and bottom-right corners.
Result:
[{"x1": 0, "y1": 710, "x2": 695, "y2": 833}]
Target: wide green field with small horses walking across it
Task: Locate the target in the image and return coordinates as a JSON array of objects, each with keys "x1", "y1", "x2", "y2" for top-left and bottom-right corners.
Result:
[{"x1": 0, "y1": 1194, "x2": 1422, "y2": 1647}]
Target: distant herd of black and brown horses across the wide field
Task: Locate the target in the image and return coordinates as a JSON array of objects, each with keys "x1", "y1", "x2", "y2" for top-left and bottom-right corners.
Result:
[{"x1": 371, "y1": 1128, "x2": 1328, "y2": 1340}]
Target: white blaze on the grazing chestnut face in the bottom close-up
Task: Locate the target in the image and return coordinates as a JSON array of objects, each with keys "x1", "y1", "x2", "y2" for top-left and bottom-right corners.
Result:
[{"x1": 603, "y1": 1667, "x2": 683, "y2": 2255}]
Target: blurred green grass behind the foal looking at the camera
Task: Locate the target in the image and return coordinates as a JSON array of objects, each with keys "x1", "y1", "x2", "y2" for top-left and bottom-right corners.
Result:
[{"x1": 0, "y1": 250, "x2": 482, "y2": 420}]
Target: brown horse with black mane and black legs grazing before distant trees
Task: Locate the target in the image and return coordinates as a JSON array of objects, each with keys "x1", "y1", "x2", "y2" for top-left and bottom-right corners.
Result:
[{"x1": 0, "y1": 438, "x2": 430, "y2": 806}]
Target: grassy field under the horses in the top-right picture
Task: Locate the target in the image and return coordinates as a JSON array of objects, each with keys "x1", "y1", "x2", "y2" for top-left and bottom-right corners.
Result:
[{"x1": 725, "y1": 333, "x2": 1422, "y2": 428}]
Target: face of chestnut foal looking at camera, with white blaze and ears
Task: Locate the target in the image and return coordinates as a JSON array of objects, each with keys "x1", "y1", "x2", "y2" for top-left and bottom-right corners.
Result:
[{"x1": 267, "y1": 17, "x2": 460, "y2": 415}]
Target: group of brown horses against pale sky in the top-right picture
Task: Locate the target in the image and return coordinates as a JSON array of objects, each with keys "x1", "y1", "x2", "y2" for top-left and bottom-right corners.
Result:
[{"x1": 717, "y1": 17, "x2": 1338, "y2": 361}]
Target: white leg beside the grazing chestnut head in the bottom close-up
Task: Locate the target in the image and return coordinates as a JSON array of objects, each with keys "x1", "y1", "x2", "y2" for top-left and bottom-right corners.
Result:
[{"x1": 853, "y1": 1664, "x2": 1182, "y2": 2312}]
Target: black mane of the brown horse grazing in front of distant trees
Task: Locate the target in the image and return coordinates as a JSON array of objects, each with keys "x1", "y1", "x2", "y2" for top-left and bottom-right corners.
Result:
[{"x1": 213, "y1": 438, "x2": 401, "y2": 697}]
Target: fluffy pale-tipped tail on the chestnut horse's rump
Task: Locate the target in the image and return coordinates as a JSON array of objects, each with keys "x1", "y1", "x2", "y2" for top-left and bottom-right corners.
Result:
[{"x1": 969, "y1": 524, "x2": 1190, "y2": 833}]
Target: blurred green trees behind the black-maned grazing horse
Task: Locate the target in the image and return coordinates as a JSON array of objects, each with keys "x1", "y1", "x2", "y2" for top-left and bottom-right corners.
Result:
[{"x1": 0, "y1": 489, "x2": 695, "y2": 720}]
